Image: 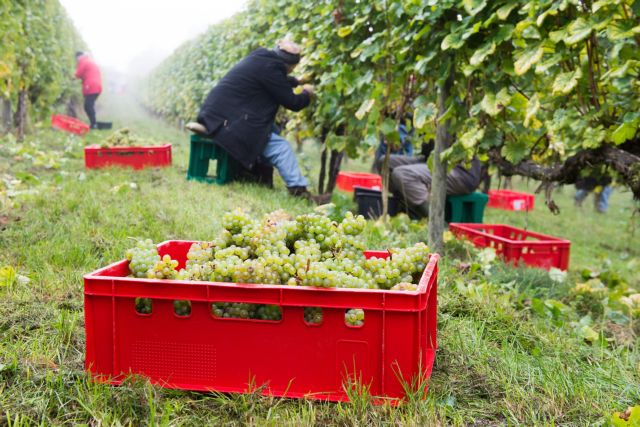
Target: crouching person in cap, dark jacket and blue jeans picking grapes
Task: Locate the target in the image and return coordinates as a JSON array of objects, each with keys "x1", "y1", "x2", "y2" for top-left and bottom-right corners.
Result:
[{"x1": 187, "y1": 40, "x2": 326, "y2": 203}]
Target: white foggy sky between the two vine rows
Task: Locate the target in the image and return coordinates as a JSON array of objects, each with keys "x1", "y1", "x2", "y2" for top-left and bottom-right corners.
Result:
[{"x1": 60, "y1": 0, "x2": 246, "y2": 77}]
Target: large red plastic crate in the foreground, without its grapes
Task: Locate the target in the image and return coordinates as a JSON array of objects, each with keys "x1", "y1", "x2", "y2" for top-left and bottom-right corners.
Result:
[{"x1": 84, "y1": 241, "x2": 439, "y2": 402}]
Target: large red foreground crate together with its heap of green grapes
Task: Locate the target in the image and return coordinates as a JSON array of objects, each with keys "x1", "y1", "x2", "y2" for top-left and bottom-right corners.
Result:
[{"x1": 85, "y1": 211, "x2": 438, "y2": 402}]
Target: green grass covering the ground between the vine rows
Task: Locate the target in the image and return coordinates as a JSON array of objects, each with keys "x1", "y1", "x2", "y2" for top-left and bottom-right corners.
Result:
[{"x1": 0, "y1": 94, "x2": 640, "y2": 426}]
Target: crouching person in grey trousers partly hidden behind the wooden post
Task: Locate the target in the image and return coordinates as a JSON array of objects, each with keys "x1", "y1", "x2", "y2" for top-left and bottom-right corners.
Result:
[{"x1": 378, "y1": 141, "x2": 482, "y2": 218}]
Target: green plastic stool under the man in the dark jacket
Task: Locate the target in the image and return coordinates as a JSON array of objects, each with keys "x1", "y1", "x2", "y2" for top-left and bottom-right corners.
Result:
[{"x1": 187, "y1": 135, "x2": 242, "y2": 185}]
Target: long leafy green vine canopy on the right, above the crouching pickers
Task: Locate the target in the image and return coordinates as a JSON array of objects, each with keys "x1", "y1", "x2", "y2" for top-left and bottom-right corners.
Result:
[{"x1": 146, "y1": 0, "x2": 640, "y2": 194}]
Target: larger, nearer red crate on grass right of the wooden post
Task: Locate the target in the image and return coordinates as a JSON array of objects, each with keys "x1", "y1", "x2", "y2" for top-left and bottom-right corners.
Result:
[{"x1": 449, "y1": 223, "x2": 571, "y2": 270}]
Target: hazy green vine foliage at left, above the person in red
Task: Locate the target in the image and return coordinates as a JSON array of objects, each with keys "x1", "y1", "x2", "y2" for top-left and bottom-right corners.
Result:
[{"x1": 0, "y1": 0, "x2": 84, "y2": 127}]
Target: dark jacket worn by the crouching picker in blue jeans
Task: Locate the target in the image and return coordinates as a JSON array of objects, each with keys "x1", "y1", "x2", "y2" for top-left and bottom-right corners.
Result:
[{"x1": 198, "y1": 48, "x2": 310, "y2": 169}]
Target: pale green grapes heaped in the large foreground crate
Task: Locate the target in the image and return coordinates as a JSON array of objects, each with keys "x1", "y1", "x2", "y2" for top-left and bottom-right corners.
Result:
[{"x1": 126, "y1": 210, "x2": 429, "y2": 326}]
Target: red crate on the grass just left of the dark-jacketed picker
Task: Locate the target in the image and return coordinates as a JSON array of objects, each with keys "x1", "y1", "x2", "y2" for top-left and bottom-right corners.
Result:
[{"x1": 84, "y1": 144, "x2": 171, "y2": 169}]
